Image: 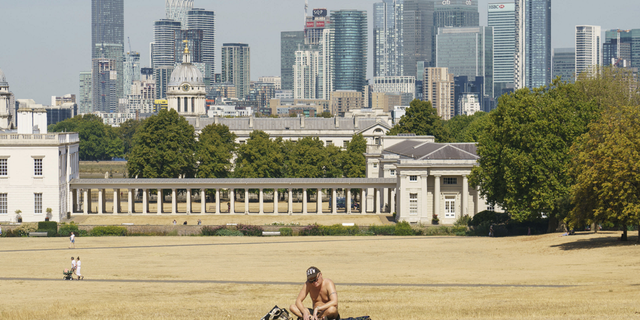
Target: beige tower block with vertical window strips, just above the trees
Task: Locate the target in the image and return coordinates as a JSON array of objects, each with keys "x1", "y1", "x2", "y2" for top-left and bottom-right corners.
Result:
[{"x1": 422, "y1": 68, "x2": 455, "y2": 120}]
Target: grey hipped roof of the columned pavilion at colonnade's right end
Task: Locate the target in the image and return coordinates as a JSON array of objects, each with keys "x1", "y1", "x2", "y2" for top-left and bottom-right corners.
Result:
[{"x1": 384, "y1": 140, "x2": 480, "y2": 160}]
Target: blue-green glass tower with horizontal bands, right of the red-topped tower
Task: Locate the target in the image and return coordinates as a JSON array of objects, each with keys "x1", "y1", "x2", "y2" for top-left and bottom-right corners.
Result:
[{"x1": 331, "y1": 10, "x2": 368, "y2": 92}]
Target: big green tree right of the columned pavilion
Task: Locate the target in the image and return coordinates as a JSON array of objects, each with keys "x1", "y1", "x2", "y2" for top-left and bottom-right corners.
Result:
[{"x1": 471, "y1": 79, "x2": 597, "y2": 221}]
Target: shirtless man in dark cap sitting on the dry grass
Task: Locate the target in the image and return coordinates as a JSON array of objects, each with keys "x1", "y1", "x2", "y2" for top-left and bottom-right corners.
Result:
[{"x1": 289, "y1": 267, "x2": 340, "y2": 320}]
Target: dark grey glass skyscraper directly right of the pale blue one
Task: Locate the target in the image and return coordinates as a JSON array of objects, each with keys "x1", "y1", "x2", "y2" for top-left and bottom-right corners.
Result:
[{"x1": 402, "y1": 0, "x2": 434, "y2": 76}]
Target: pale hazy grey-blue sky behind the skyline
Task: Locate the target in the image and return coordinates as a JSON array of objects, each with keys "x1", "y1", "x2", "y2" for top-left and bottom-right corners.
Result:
[{"x1": 0, "y1": 0, "x2": 640, "y2": 105}]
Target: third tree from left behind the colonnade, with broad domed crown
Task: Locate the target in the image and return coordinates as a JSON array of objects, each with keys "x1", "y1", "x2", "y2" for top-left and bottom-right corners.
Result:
[{"x1": 234, "y1": 130, "x2": 284, "y2": 178}]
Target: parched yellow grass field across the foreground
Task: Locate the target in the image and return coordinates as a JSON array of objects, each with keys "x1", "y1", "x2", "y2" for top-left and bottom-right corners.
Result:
[{"x1": 0, "y1": 232, "x2": 640, "y2": 320}]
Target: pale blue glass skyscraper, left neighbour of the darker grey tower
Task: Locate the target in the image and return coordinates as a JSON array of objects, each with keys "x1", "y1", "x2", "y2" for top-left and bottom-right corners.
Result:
[{"x1": 373, "y1": 0, "x2": 404, "y2": 77}]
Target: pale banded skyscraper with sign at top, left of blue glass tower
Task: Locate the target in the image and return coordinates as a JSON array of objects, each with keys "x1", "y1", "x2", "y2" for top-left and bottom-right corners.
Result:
[{"x1": 487, "y1": 2, "x2": 516, "y2": 97}]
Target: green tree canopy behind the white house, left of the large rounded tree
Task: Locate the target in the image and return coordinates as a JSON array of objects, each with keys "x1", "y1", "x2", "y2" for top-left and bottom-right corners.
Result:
[{"x1": 48, "y1": 114, "x2": 124, "y2": 161}]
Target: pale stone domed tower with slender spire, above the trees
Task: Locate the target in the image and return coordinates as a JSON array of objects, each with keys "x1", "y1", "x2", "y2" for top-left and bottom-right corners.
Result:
[{"x1": 167, "y1": 40, "x2": 206, "y2": 117}]
